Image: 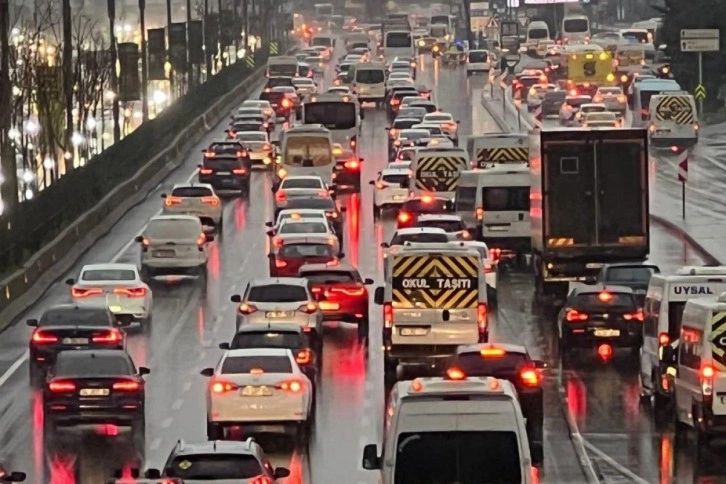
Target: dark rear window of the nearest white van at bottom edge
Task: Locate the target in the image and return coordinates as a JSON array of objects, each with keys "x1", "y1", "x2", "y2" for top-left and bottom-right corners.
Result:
[{"x1": 394, "y1": 431, "x2": 522, "y2": 484}]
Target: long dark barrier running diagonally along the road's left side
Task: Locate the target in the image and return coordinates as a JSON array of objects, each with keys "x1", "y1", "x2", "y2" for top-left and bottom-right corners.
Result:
[{"x1": 0, "y1": 42, "x2": 295, "y2": 330}]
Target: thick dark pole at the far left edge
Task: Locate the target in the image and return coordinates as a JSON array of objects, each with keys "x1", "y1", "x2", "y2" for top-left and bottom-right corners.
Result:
[{"x1": 0, "y1": 0, "x2": 18, "y2": 214}]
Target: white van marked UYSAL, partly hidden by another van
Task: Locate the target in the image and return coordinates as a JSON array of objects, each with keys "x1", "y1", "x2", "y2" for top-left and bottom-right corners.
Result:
[{"x1": 640, "y1": 266, "x2": 726, "y2": 407}]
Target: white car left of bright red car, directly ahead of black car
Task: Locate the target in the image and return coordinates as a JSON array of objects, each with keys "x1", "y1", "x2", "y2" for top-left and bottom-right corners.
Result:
[{"x1": 230, "y1": 278, "x2": 323, "y2": 342}]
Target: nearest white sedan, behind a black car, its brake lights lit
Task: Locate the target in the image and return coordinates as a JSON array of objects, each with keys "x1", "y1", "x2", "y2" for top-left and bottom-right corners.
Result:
[{"x1": 201, "y1": 348, "x2": 314, "y2": 442}]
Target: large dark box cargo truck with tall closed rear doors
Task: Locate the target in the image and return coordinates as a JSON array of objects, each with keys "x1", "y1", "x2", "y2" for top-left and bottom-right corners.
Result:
[{"x1": 529, "y1": 129, "x2": 650, "y2": 299}]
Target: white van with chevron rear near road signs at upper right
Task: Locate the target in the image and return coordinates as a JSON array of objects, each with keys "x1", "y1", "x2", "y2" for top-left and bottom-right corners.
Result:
[{"x1": 648, "y1": 92, "x2": 699, "y2": 147}]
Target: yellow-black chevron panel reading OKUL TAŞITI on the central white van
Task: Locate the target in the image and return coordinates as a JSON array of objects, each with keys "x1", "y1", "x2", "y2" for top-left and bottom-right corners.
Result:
[{"x1": 392, "y1": 255, "x2": 481, "y2": 309}]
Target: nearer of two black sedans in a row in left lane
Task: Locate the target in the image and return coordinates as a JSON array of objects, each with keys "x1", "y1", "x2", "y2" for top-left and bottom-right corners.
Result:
[{"x1": 43, "y1": 349, "x2": 150, "y2": 442}]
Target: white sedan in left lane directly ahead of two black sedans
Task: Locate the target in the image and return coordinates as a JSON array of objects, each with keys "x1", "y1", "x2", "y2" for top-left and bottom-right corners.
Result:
[{"x1": 66, "y1": 263, "x2": 153, "y2": 326}]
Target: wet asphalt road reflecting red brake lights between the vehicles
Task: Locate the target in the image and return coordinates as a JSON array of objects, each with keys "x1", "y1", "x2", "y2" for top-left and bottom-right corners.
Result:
[{"x1": 0, "y1": 43, "x2": 716, "y2": 484}]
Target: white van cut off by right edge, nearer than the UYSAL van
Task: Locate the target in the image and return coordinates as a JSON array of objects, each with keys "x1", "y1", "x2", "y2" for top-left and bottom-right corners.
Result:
[{"x1": 668, "y1": 294, "x2": 726, "y2": 452}]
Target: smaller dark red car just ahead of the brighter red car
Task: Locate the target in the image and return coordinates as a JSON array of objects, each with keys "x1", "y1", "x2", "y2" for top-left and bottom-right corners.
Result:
[{"x1": 269, "y1": 234, "x2": 343, "y2": 277}]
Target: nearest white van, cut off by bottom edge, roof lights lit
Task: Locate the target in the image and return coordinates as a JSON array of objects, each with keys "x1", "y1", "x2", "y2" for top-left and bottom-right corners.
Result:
[{"x1": 363, "y1": 376, "x2": 532, "y2": 484}]
